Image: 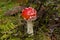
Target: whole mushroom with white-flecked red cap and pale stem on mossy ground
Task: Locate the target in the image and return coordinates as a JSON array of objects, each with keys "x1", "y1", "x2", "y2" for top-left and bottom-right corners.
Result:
[{"x1": 22, "y1": 7, "x2": 37, "y2": 35}]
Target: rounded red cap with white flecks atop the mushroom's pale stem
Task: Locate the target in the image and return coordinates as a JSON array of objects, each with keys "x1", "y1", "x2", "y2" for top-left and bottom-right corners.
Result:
[{"x1": 22, "y1": 7, "x2": 37, "y2": 21}]
